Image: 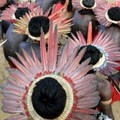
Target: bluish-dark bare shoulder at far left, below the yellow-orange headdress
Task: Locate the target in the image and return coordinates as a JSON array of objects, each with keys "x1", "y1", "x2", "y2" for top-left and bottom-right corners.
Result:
[{"x1": 3, "y1": 24, "x2": 27, "y2": 63}]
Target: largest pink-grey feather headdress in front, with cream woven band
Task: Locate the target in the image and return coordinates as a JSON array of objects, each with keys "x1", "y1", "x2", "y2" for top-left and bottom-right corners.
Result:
[{"x1": 2, "y1": 22, "x2": 99, "y2": 120}]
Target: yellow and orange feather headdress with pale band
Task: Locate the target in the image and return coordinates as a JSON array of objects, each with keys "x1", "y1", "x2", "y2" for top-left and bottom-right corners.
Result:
[{"x1": 14, "y1": 0, "x2": 72, "y2": 41}]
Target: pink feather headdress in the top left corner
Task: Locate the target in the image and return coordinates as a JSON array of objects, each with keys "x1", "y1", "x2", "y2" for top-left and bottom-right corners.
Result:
[{"x1": 1, "y1": 2, "x2": 37, "y2": 22}]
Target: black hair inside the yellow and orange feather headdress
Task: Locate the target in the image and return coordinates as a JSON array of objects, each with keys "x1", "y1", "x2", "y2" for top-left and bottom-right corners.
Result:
[{"x1": 28, "y1": 16, "x2": 50, "y2": 37}]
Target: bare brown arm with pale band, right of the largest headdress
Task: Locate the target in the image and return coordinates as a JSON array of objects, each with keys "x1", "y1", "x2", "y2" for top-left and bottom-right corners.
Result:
[{"x1": 97, "y1": 72, "x2": 114, "y2": 120}]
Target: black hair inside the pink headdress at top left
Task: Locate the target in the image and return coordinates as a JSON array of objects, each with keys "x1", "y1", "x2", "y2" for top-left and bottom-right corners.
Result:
[{"x1": 15, "y1": 7, "x2": 30, "y2": 19}]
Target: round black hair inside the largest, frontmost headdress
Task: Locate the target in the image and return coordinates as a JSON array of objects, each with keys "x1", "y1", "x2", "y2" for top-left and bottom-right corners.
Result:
[{"x1": 32, "y1": 77, "x2": 66, "y2": 119}]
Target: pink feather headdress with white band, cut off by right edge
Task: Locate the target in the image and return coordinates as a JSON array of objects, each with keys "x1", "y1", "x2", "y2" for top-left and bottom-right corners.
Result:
[{"x1": 94, "y1": 0, "x2": 120, "y2": 27}]
